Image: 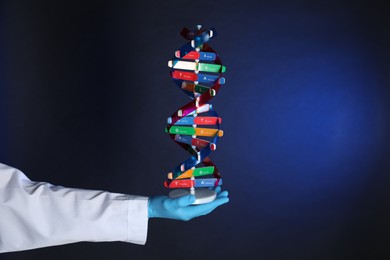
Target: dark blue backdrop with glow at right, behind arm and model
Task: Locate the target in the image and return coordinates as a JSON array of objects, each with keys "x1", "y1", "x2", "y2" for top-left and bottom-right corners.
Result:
[{"x1": 0, "y1": 0, "x2": 390, "y2": 260}]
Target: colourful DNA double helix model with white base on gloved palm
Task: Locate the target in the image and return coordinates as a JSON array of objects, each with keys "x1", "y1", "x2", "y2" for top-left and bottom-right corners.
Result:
[{"x1": 164, "y1": 25, "x2": 226, "y2": 204}]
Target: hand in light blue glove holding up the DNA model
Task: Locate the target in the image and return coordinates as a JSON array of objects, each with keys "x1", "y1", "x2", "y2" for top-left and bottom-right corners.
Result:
[{"x1": 148, "y1": 186, "x2": 229, "y2": 221}]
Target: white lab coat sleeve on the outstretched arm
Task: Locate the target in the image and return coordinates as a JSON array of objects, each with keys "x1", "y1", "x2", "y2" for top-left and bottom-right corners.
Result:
[{"x1": 0, "y1": 163, "x2": 148, "y2": 252}]
